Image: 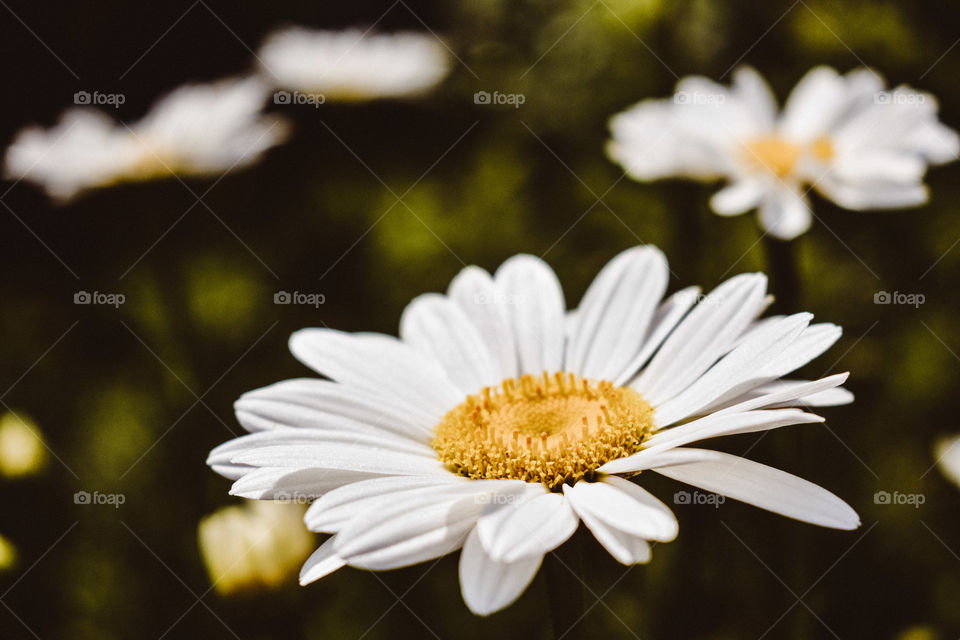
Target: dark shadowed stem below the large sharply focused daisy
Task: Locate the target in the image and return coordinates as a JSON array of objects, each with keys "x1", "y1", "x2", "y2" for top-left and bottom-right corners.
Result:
[{"x1": 543, "y1": 534, "x2": 587, "y2": 640}]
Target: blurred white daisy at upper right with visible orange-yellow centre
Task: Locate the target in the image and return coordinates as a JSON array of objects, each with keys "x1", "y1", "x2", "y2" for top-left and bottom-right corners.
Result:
[{"x1": 607, "y1": 67, "x2": 960, "y2": 239}]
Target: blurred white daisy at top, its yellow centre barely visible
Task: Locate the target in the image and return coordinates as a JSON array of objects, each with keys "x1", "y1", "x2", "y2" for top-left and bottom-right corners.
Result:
[{"x1": 258, "y1": 27, "x2": 450, "y2": 100}]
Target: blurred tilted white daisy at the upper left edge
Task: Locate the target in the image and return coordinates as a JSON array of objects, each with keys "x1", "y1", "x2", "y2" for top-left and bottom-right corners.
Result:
[{"x1": 4, "y1": 78, "x2": 287, "y2": 201}]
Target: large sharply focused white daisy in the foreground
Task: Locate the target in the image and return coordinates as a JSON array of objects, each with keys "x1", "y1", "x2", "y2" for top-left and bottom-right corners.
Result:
[{"x1": 208, "y1": 247, "x2": 859, "y2": 615}]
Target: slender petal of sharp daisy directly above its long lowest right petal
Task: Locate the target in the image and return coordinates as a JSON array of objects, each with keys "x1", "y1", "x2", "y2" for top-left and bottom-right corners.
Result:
[{"x1": 597, "y1": 409, "x2": 823, "y2": 473}]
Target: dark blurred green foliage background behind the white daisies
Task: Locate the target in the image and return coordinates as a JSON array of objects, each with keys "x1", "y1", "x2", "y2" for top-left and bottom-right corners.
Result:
[{"x1": 0, "y1": 0, "x2": 960, "y2": 640}]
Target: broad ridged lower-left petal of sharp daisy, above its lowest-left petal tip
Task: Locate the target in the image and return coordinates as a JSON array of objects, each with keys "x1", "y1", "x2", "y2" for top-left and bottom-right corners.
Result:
[{"x1": 336, "y1": 480, "x2": 525, "y2": 571}]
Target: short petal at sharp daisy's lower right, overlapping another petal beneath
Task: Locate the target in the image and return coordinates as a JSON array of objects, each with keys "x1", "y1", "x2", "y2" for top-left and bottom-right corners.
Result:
[{"x1": 564, "y1": 476, "x2": 678, "y2": 542}]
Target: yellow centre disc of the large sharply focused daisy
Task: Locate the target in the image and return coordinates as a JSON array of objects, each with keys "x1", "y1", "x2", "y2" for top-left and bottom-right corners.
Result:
[{"x1": 432, "y1": 372, "x2": 653, "y2": 489}]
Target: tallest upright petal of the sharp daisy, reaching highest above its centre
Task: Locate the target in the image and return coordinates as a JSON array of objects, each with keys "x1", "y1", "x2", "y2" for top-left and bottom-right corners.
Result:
[{"x1": 564, "y1": 247, "x2": 669, "y2": 380}]
